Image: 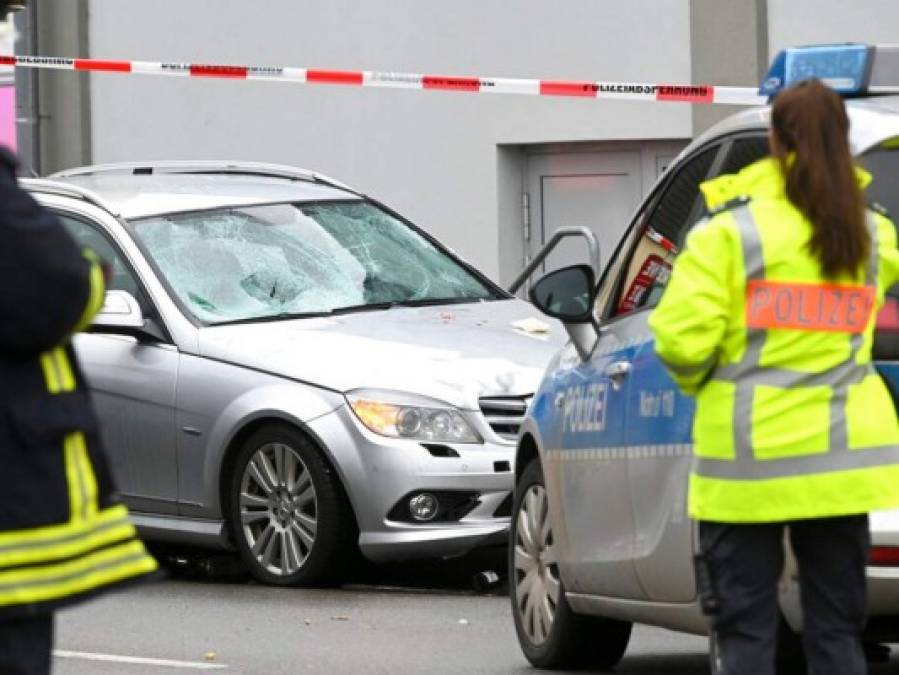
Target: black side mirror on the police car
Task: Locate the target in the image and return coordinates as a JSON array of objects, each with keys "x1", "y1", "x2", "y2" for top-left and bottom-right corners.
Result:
[{"x1": 529, "y1": 265, "x2": 599, "y2": 361}]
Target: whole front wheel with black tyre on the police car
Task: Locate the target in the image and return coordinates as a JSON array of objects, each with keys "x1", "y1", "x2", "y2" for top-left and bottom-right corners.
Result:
[{"x1": 509, "y1": 459, "x2": 631, "y2": 669}]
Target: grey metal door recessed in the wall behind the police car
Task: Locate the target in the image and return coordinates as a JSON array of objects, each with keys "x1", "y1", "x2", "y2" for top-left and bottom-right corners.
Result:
[{"x1": 527, "y1": 149, "x2": 655, "y2": 270}]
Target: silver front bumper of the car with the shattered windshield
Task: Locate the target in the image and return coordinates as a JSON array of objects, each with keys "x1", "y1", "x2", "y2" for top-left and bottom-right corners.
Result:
[{"x1": 308, "y1": 406, "x2": 515, "y2": 561}]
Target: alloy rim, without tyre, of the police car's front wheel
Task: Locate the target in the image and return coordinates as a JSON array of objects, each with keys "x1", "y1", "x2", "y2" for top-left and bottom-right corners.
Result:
[{"x1": 513, "y1": 485, "x2": 561, "y2": 646}]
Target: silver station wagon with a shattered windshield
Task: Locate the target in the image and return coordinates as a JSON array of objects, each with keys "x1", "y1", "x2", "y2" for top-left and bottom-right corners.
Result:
[{"x1": 24, "y1": 162, "x2": 561, "y2": 584}]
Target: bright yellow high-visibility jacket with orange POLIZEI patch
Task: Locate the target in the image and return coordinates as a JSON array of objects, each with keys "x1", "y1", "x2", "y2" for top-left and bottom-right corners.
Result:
[{"x1": 649, "y1": 158, "x2": 899, "y2": 523}]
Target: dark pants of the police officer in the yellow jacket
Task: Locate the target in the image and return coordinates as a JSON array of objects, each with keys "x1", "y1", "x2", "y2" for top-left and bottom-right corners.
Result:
[{"x1": 699, "y1": 515, "x2": 870, "y2": 675}]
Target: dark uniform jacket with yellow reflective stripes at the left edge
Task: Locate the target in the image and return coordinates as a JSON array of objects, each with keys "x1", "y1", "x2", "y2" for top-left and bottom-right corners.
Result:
[{"x1": 0, "y1": 149, "x2": 156, "y2": 618}]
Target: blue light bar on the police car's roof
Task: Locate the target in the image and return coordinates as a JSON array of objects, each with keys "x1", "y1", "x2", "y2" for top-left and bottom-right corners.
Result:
[{"x1": 759, "y1": 43, "x2": 874, "y2": 97}]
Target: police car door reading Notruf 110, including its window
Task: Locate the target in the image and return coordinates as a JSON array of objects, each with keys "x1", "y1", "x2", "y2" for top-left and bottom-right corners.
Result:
[{"x1": 609, "y1": 137, "x2": 767, "y2": 602}]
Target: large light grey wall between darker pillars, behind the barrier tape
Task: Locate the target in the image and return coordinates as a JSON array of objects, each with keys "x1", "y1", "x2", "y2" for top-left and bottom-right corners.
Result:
[{"x1": 90, "y1": 0, "x2": 692, "y2": 282}]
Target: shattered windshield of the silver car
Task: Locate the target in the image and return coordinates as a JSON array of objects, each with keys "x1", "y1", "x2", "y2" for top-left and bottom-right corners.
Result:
[{"x1": 135, "y1": 201, "x2": 499, "y2": 324}]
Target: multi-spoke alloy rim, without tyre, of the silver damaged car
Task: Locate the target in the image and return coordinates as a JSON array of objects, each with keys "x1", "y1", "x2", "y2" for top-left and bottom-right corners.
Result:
[{"x1": 239, "y1": 443, "x2": 318, "y2": 576}]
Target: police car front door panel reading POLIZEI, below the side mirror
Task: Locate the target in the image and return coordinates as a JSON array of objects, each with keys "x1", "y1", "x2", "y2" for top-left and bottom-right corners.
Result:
[{"x1": 534, "y1": 302, "x2": 639, "y2": 598}]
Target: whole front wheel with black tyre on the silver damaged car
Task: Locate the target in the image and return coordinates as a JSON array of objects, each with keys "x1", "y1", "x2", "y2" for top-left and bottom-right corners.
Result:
[{"x1": 229, "y1": 424, "x2": 357, "y2": 586}]
